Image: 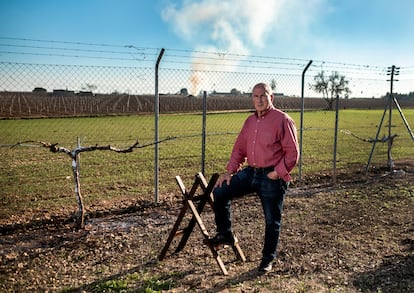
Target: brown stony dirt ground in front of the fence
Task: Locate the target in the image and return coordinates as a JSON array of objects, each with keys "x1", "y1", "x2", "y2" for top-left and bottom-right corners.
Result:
[{"x1": 0, "y1": 159, "x2": 414, "y2": 292}]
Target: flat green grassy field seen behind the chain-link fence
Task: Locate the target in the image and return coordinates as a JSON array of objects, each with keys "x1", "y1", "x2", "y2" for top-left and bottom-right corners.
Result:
[{"x1": 0, "y1": 109, "x2": 414, "y2": 218}]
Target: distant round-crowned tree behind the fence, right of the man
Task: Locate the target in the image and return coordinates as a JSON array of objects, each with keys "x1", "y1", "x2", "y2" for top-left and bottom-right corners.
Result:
[{"x1": 310, "y1": 70, "x2": 351, "y2": 110}]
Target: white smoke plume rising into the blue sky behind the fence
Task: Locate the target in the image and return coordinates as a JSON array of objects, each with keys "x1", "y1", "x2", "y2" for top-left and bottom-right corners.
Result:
[{"x1": 161, "y1": 0, "x2": 323, "y2": 94}]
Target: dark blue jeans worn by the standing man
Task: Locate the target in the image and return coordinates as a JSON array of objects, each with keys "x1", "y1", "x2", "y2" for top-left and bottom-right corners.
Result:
[{"x1": 213, "y1": 167, "x2": 289, "y2": 262}]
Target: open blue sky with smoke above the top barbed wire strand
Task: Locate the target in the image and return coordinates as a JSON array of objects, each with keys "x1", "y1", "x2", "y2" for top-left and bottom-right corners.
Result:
[{"x1": 0, "y1": 0, "x2": 414, "y2": 94}]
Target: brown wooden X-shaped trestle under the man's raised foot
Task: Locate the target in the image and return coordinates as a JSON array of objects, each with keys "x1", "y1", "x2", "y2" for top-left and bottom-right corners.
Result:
[{"x1": 158, "y1": 172, "x2": 246, "y2": 275}]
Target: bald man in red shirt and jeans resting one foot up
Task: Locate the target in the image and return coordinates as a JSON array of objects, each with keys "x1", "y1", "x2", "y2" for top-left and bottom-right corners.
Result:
[{"x1": 210, "y1": 83, "x2": 299, "y2": 273}]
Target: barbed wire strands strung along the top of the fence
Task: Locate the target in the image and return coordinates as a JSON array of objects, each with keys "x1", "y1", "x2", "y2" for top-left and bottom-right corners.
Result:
[{"x1": 0, "y1": 37, "x2": 408, "y2": 76}]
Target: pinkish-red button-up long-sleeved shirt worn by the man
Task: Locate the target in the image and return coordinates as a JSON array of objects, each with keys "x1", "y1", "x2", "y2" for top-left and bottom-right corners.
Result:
[{"x1": 227, "y1": 107, "x2": 299, "y2": 181}]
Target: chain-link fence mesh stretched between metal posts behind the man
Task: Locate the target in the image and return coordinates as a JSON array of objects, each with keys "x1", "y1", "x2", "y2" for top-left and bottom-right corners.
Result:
[{"x1": 0, "y1": 54, "x2": 414, "y2": 207}]
